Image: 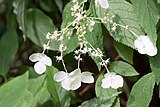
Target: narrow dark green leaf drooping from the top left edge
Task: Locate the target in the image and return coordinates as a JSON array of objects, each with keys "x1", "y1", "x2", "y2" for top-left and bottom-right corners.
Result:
[{"x1": 13, "y1": 0, "x2": 27, "y2": 39}]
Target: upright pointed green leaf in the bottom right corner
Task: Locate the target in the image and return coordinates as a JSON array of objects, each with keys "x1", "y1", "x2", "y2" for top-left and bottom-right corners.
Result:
[{"x1": 127, "y1": 73, "x2": 155, "y2": 107}]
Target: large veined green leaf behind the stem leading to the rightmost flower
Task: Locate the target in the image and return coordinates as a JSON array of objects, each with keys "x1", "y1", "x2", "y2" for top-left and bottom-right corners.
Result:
[{"x1": 104, "y1": 0, "x2": 144, "y2": 49}]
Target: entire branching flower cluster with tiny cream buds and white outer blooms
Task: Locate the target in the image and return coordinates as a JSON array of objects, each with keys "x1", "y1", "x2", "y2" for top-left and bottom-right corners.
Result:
[{"x1": 29, "y1": 0, "x2": 157, "y2": 90}]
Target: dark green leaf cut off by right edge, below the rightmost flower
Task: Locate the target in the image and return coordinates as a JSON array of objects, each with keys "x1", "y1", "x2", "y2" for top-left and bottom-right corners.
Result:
[{"x1": 149, "y1": 33, "x2": 160, "y2": 84}]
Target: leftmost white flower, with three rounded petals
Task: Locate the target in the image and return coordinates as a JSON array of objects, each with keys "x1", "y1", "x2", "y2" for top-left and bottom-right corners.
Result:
[{"x1": 29, "y1": 53, "x2": 52, "y2": 74}]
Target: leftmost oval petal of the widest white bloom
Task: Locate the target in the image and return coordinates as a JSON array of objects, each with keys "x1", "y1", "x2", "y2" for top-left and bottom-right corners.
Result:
[{"x1": 54, "y1": 71, "x2": 67, "y2": 82}]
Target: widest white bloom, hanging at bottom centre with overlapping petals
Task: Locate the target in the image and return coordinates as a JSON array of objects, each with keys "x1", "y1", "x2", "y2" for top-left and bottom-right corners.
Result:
[{"x1": 54, "y1": 69, "x2": 94, "y2": 90}]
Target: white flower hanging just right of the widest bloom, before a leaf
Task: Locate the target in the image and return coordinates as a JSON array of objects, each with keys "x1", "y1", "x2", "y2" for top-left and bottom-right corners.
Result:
[{"x1": 101, "y1": 72, "x2": 123, "y2": 89}]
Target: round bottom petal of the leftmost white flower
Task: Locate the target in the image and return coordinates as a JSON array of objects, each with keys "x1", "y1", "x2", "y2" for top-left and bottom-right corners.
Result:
[{"x1": 34, "y1": 62, "x2": 46, "y2": 74}]
